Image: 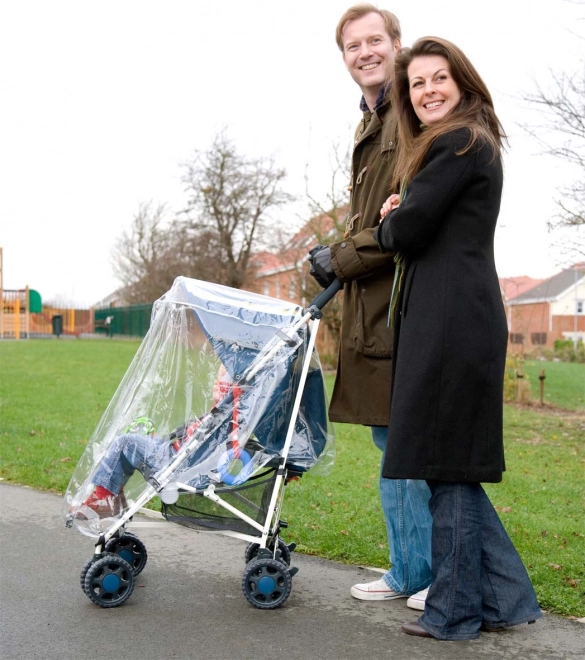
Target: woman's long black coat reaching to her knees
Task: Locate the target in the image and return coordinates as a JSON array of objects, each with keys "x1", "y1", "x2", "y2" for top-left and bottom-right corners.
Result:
[{"x1": 375, "y1": 129, "x2": 508, "y2": 482}]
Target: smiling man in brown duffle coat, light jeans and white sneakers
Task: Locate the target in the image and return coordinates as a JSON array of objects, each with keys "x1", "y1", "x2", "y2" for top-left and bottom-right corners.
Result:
[{"x1": 309, "y1": 4, "x2": 431, "y2": 609}]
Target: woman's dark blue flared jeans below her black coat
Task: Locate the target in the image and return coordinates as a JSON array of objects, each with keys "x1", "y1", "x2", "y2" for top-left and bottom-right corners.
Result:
[{"x1": 419, "y1": 481, "x2": 542, "y2": 640}]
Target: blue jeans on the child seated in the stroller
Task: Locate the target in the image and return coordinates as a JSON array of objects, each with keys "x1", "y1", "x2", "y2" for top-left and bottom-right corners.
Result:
[{"x1": 92, "y1": 433, "x2": 175, "y2": 495}]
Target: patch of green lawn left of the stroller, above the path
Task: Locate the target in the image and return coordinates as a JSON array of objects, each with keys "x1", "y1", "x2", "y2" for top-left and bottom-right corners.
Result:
[{"x1": 0, "y1": 339, "x2": 140, "y2": 493}]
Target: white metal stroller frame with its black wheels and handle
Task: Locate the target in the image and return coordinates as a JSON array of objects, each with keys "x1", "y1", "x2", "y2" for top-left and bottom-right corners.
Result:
[{"x1": 81, "y1": 279, "x2": 343, "y2": 609}]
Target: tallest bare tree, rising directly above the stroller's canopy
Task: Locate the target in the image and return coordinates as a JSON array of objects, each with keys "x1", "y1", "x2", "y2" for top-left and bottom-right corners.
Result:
[{"x1": 182, "y1": 130, "x2": 292, "y2": 288}]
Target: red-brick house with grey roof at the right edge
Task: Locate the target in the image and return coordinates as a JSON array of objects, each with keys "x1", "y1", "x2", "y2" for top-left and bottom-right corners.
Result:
[{"x1": 500, "y1": 263, "x2": 585, "y2": 353}]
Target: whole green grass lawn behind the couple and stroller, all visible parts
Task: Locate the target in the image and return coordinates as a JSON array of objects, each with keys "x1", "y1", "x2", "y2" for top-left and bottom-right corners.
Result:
[{"x1": 0, "y1": 340, "x2": 585, "y2": 616}]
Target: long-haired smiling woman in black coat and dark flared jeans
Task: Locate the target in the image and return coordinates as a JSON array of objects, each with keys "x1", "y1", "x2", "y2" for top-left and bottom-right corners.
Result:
[{"x1": 375, "y1": 37, "x2": 541, "y2": 640}]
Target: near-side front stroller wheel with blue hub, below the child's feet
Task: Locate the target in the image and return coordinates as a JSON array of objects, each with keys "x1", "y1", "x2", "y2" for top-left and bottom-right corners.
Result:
[{"x1": 83, "y1": 553, "x2": 134, "y2": 607}]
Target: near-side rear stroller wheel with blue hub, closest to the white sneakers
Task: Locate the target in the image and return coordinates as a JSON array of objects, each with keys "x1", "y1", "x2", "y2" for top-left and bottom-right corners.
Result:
[{"x1": 242, "y1": 559, "x2": 292, "y2": 610}]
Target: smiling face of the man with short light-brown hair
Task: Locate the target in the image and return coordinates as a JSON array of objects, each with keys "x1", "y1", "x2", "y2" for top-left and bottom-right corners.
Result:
[{"x1": 342, "y1": 12, "x2": 400, "y2": 95}]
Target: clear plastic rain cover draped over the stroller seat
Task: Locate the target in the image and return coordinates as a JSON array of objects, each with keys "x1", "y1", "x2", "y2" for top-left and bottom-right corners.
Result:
[{"x1": 63, "y1": 277, "x2": 334, "y2": 536}]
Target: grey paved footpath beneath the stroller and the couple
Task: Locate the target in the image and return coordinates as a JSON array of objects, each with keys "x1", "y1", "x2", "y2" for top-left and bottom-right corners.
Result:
[{"x1": 0, "y1": 484, "x2": 585, "y2": 660}]
